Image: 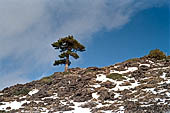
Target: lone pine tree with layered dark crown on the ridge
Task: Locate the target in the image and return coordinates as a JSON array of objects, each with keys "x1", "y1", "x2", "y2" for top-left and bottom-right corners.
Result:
[{"x1": 52, "y1": 35, "x2": 85, "y2": 72}]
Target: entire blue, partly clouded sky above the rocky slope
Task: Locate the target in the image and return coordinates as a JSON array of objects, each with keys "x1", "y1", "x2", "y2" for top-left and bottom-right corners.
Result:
[{"x1": 0, "y1": 0, "x2": 170, "y2": 89}]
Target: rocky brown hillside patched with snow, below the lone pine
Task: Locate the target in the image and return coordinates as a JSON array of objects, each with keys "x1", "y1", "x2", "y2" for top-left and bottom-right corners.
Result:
[{"x1": 0, "y1": 57, "x2": 170, "y2": 113}]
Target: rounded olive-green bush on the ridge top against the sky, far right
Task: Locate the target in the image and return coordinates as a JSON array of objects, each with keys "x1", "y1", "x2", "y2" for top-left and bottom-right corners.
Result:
[{"x1": 148, "y1": 49, "x2": 166, "y2": 60}]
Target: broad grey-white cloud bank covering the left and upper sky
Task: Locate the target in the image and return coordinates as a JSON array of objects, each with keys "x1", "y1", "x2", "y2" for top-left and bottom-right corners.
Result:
[{"x1": 0, "y1": 0, "x2": 168, "y2": 87}]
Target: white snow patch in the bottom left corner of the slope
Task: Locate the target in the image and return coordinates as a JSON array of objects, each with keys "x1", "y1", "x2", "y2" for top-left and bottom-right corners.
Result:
[{"x1": 0, "y1": 100, "x2": 30, "y2": 110}]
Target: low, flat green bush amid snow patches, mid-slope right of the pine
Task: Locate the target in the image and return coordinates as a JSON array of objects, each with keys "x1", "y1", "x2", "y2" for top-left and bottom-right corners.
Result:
[{"x1": 106, "y1": 73, "x2": 126, "y2": 81}]
